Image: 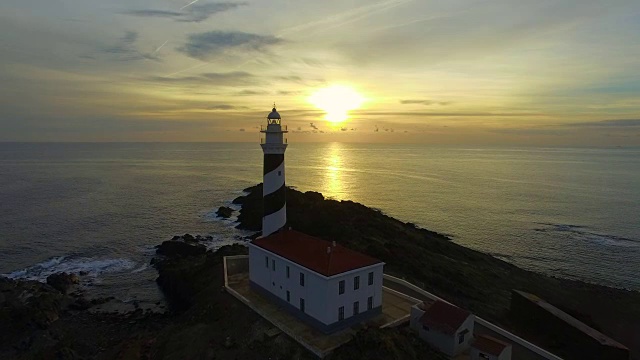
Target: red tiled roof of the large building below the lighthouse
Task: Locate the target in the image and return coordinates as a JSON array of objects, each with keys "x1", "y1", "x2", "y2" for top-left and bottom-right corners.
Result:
[{"x1": 252, "y1": 230, "x2": 382, "y2": 276}]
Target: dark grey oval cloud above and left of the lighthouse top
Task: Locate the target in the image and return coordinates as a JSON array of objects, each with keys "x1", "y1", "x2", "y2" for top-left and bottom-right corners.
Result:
[{"x1": 178, "y1": 31, "x2": 283, "y2": 60}]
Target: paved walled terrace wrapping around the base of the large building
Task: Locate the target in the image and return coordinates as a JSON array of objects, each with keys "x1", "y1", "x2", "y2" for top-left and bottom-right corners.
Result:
[{"x1": 224, "y1": 255, "x2": 420, "y2": 358}]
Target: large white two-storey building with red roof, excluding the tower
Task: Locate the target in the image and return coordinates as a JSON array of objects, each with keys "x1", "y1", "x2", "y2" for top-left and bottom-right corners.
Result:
[{"x1": 249, "y1": 230, "x2": 384, "y2": 333}]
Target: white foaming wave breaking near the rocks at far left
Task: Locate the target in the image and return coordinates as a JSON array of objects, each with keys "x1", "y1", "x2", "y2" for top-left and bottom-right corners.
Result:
[{"x1": 3, "y1": 256, "x2": 136, "y2": 282}]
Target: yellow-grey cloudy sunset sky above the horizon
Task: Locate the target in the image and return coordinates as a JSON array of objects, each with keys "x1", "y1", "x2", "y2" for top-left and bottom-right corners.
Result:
[{"x1": 0, "y1": 0, "x2": 640, "y2": 146}]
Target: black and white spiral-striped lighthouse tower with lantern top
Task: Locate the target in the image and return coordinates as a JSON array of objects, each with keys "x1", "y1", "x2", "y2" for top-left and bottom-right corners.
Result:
[{"x1": 260, "y1": 104, "x2": 287, "y2": 236}]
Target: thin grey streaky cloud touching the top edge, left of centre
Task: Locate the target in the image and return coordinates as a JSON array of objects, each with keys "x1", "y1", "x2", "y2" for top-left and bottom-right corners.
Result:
[{"x1": 123, "y1": 2, "x2": 247, "y2": 22}]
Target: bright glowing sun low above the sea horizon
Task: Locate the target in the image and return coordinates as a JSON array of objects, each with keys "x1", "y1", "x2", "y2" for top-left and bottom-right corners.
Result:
[{"x1": 309, "y1": 85, "x2": 365, "y2": 123}]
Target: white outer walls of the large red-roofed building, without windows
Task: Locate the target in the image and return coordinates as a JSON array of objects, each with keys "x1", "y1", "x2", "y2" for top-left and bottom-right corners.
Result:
[{"x1": 249, "y1": 244, "x2": 384, "y2": 325}]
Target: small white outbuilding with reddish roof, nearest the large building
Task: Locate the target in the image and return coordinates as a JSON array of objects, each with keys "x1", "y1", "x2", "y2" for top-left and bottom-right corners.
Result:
[{"x1": 409, "y1": 300, "x2": 475, "y2": 356}]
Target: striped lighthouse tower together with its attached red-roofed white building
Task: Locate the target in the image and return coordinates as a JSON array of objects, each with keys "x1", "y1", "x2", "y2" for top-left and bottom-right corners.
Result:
[{"x1": 249, "y1": 104, "x2": 384, "y2": 333}]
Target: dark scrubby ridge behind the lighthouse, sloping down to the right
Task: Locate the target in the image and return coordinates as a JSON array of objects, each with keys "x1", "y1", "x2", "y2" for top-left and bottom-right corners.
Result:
[{"x1": 234, "y1": 184, "x2": 640, "y2": 356}]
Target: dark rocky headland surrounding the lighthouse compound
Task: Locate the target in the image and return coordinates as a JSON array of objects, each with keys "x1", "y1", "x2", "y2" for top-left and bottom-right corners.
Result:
[{"x1": 0, "y1": 185, "x2": 640, "y2": 359}]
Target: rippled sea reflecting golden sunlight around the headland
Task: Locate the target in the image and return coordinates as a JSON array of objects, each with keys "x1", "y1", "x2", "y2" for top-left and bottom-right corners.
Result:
[{"x1": 0, "y1": 143, "x2": 640, "y2": 305}]
